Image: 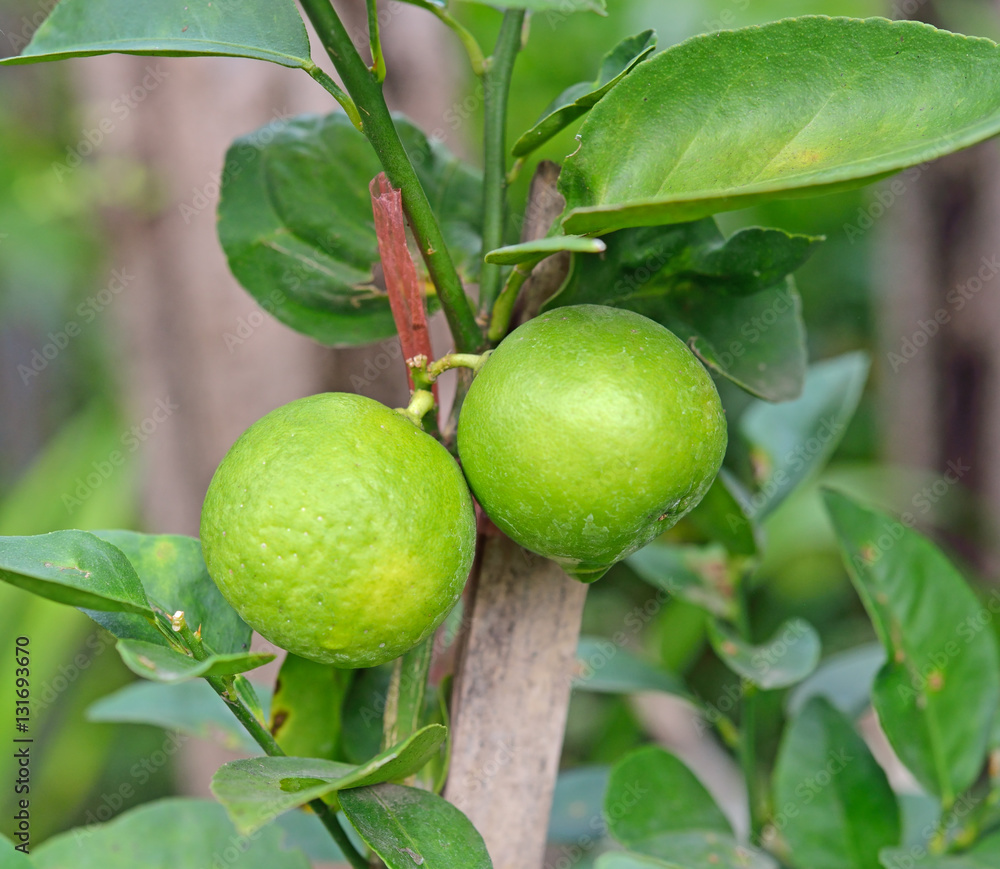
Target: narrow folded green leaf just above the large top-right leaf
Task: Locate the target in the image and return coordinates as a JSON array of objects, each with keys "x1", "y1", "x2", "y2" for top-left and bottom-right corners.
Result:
[{"x1": 513, "y1": 30, "x2": 656, "y2": 157}]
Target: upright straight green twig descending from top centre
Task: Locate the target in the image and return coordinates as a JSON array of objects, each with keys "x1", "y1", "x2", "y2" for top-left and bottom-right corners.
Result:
[{"x1": 479, "y1": 9, "x2": 525, "y2": 314}]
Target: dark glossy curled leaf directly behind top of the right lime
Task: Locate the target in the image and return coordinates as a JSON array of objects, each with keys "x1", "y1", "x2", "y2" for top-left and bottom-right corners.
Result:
[{"x1": 545, "y1": 220, "x2": 819, "y2": 401}]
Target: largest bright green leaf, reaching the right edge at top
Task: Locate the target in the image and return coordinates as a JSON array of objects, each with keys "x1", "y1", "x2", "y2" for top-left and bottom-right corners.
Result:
[{"x1": 559, "y1": 16, "x2": 1000, "y2": 234}]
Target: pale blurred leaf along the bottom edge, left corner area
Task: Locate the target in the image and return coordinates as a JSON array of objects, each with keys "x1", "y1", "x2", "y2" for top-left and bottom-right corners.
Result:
[{"x1": 33, "y1": 799, "x2": 309, "y2": 869}]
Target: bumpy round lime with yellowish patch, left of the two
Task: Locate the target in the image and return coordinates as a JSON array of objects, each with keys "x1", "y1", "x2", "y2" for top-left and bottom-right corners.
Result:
[{"x1": 201, "y1": 393, "x2": 476, "y2": 667}]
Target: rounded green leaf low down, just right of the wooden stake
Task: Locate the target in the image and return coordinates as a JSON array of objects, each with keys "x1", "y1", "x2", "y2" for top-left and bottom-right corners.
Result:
[{"x1": 604, "y1": 746, "x2": 732, "y2": 847}]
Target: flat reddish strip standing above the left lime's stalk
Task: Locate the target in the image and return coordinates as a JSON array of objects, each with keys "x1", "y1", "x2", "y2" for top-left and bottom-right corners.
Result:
[{"x1": 368, "y1": 172, "x2": 437, "y2": 399}]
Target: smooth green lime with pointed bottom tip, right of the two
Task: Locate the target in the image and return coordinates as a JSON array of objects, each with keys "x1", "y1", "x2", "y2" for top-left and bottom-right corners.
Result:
[{"x1": 458, "y1": 305, "x2": 727, "y2": 582}]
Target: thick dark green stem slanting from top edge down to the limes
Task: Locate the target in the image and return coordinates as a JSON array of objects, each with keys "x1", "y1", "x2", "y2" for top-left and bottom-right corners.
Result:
[{"x1": 302, "y1": 0, "x2": 483, "y2": 353}]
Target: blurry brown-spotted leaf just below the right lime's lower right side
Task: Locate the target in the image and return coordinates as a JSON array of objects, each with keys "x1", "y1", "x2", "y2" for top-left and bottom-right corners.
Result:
[{"x1": 625, "y1": 542, "x2": 736, "y2": 619}]
